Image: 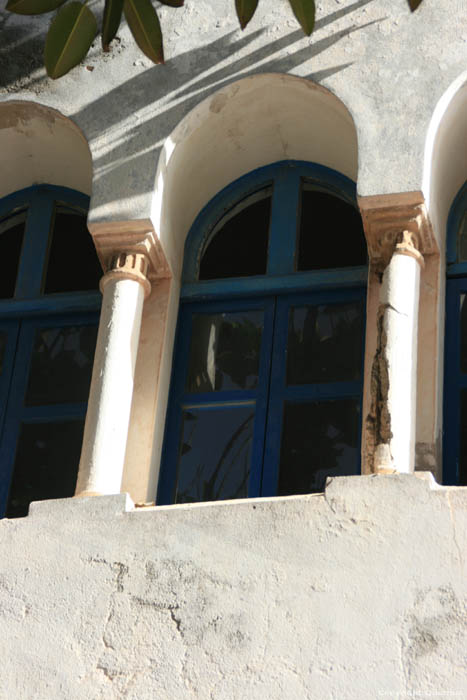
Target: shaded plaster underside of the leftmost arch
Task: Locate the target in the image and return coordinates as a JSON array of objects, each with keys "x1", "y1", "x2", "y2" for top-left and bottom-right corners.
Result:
[{"x1": 0, "y1": 100, "x2": 92, "y2": 198}]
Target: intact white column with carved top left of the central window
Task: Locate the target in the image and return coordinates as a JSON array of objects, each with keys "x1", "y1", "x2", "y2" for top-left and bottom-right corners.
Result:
[{"x1": 75, "y1": 253, "x2": 151, "y2": 496}]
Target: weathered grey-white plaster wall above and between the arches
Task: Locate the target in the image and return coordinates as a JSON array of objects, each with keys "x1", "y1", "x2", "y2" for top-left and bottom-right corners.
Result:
[{"x1": 0, "y1": 0, "x2": 467, "y2": 221}]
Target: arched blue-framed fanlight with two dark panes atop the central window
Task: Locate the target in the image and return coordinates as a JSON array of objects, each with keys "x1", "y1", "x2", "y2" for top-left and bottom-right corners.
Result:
[{"x1": 183, "y1": 161, "x2": 367, "y2": 284}]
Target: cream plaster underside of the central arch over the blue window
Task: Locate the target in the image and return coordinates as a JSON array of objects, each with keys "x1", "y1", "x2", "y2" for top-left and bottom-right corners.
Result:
[{"x1": 152, "y1": 74, "x2": 358, "y2": 277}]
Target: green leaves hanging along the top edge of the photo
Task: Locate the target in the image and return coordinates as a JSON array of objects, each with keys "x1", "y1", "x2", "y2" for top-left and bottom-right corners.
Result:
[{"x1": 6, "y1": 0, "x2": 422, "y2": 78}]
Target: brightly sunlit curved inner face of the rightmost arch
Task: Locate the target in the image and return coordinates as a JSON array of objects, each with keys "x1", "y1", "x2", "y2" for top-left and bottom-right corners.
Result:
[{"x1": 422, "y1": 71, "x2": 467, "y2": 250}]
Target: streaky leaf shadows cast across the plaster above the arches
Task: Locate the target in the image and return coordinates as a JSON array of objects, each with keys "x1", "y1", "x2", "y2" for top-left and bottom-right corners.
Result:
[{"x1": 0, "y1": 0, "x2": 383, "y2": 218}]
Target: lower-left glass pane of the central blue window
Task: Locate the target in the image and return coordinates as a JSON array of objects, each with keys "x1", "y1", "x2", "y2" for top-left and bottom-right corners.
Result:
[{"x1": 175, "y1": 406, "x2": 254, "y2": 503}]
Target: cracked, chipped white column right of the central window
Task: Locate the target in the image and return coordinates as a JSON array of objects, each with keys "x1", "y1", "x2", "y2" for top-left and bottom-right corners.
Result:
[{"x1": 375, "y1": 231, "x2": 423, "y2": 473}]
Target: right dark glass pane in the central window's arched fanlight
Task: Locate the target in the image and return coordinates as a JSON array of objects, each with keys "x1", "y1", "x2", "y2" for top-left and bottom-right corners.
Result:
[{"x1": 297, "y1": 183, "x2": 367, "y2": 270}]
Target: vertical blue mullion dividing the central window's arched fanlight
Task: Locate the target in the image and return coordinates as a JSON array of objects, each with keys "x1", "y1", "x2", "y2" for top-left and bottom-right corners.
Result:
[{"x1": 267, "y1": 167, "x2": 301, "y2": 275}]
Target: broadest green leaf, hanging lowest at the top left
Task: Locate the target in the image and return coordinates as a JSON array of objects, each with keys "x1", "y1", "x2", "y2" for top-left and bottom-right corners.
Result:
[{"x1": 44, "y1": 2, "x2": 97, "y2": 78}]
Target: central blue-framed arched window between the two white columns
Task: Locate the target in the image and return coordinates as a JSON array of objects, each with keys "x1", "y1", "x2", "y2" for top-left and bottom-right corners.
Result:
[{"x1": 158, "y1": 162, "x2": 367, "y2": 504}]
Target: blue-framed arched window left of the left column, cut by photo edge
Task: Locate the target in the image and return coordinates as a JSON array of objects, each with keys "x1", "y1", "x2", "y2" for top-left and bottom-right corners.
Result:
[{"x1": 0, "y1": 185, "x2": 101, "y2": 517}]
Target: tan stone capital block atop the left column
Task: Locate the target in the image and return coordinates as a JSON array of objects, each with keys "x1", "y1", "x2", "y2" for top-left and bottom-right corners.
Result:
[{"x1": 89, "y1": 220, "x2": 171, "y2": 281}]
